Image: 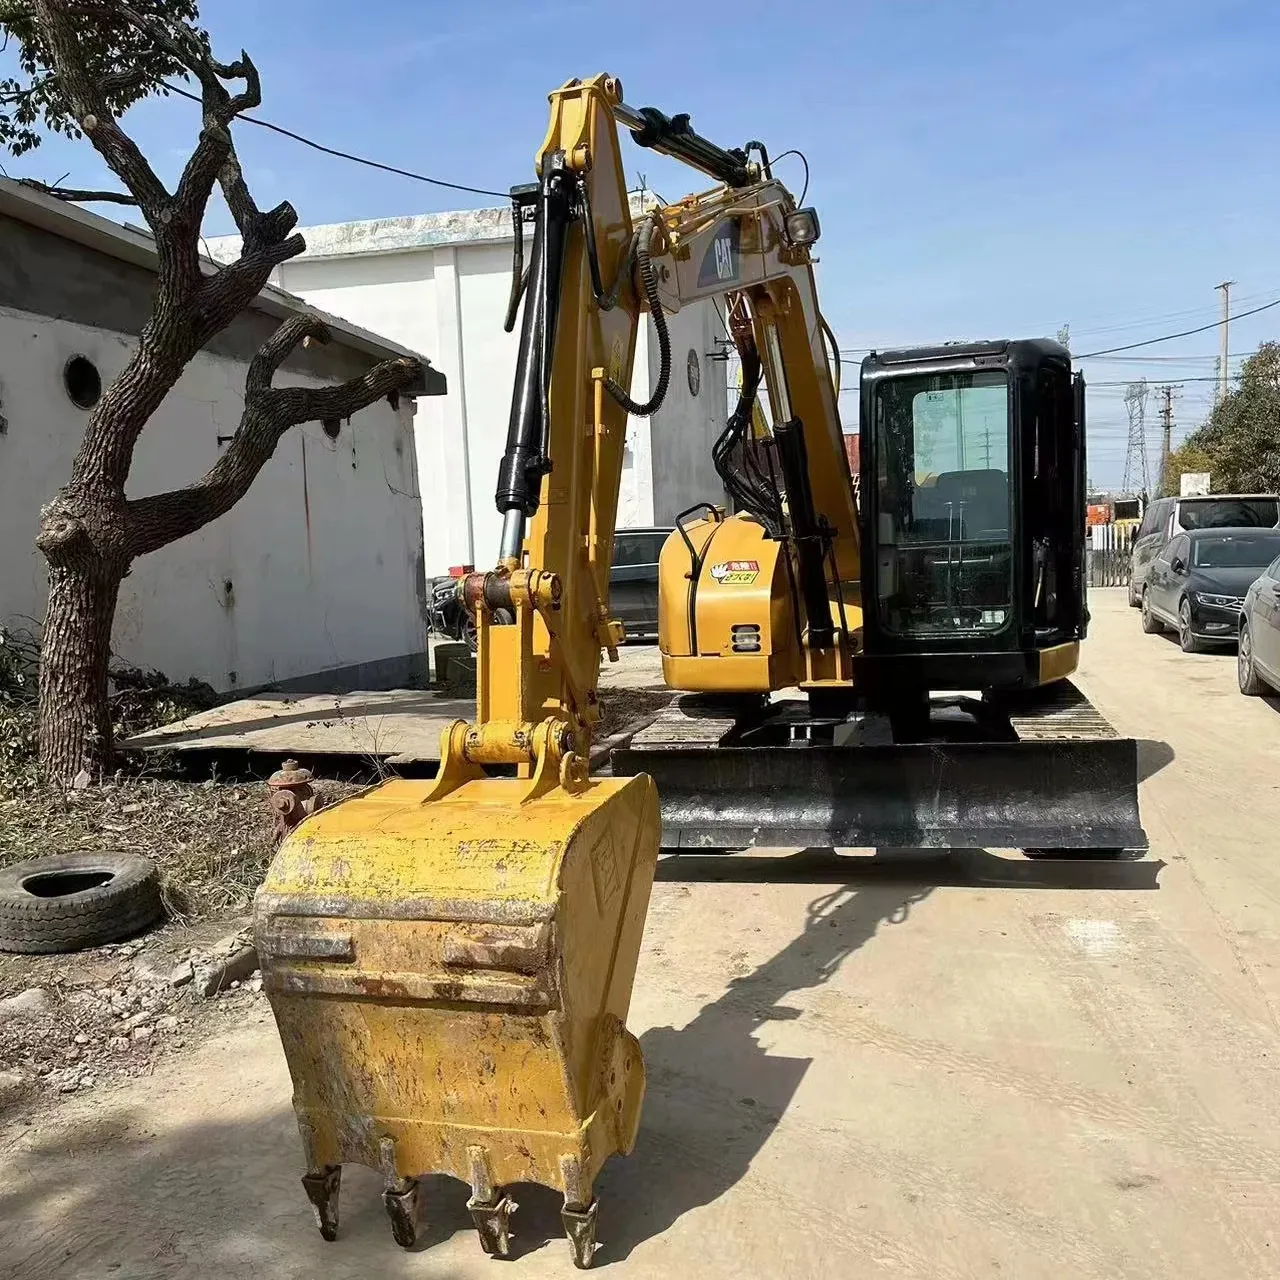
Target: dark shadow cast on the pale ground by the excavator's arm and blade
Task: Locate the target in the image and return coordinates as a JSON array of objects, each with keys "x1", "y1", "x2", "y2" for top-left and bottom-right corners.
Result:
[{"x1": 581, "y1": 850, "x2": 1164, "y2": 1267}]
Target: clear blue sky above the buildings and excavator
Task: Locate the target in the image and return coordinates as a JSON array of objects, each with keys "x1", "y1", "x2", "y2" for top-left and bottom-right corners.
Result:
[{"x1": 0, "y1": 0, "x2": 1280, "y2": 486}]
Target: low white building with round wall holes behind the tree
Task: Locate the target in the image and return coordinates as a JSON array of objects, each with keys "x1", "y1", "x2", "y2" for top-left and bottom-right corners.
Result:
[{"x1": 0, "y1": 180, "x2": 444, "y2": 690}]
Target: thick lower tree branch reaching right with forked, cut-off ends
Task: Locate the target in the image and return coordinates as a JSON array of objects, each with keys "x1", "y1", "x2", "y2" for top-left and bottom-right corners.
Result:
[{"x1": 125, "y1": 315, "x2": 420, "y2": 556}]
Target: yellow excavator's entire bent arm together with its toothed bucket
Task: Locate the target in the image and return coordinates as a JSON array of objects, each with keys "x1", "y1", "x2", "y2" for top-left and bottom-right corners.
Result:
[{"x1": 255, "y1": 76, "x2": 839, "y2": 1266}]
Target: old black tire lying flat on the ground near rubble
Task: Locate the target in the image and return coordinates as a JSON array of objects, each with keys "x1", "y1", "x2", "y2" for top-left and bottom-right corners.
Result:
[{"x1": 0, "y1": 852, "x2": 164, "y2": 955}]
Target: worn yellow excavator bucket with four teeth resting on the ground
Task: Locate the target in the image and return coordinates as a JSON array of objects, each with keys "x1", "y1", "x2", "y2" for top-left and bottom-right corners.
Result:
[{"x1": 255, "y1": 768, "x2": 658, "y2": 1267}]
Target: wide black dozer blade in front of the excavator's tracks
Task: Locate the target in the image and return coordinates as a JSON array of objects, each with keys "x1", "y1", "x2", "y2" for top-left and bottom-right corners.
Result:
[{"x1": 612, "y1": 737, "x2": 1148, "y2": 855}]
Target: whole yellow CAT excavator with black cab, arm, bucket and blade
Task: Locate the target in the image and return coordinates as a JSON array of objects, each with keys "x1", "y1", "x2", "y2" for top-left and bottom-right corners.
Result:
[{"x1": 255, "y1": 76, "x2": 1144, "y2": 1267}]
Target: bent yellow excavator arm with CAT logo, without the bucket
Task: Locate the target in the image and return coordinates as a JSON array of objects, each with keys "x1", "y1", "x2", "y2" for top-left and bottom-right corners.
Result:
[{"x1": 461, "y1": 77, "x2": 859, "y2": 769}]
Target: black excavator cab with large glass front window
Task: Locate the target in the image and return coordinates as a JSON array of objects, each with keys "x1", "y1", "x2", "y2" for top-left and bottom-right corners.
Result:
[{"x1": 855, "y1": 339, "x2": 1088, "y2": 708}]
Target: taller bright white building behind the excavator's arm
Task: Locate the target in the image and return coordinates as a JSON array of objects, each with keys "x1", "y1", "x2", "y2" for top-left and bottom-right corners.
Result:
[{"x1": 210, "y1": 205, "x2": 727, "y2": 575}]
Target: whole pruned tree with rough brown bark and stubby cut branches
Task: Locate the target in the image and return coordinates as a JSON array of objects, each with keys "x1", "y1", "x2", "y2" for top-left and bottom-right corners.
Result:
[{"x1": 12, "y1": 0, "x2": 421, "y2": 782}]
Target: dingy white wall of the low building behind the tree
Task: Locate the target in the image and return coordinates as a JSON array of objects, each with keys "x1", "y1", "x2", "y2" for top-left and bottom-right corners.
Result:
[{"x1": 0, "y1": 307, "x2": 430, "y2": 690}]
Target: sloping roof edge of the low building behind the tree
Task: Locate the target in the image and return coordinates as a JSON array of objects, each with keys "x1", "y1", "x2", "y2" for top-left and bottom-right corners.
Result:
[{"x1": 0, "y1": 178, "x2": 444, "y2": 396}]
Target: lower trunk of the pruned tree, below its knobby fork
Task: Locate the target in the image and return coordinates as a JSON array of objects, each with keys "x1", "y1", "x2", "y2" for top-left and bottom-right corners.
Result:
[{"x1": 40, "y1": 557, "x2": 123, "y2": 786}]
